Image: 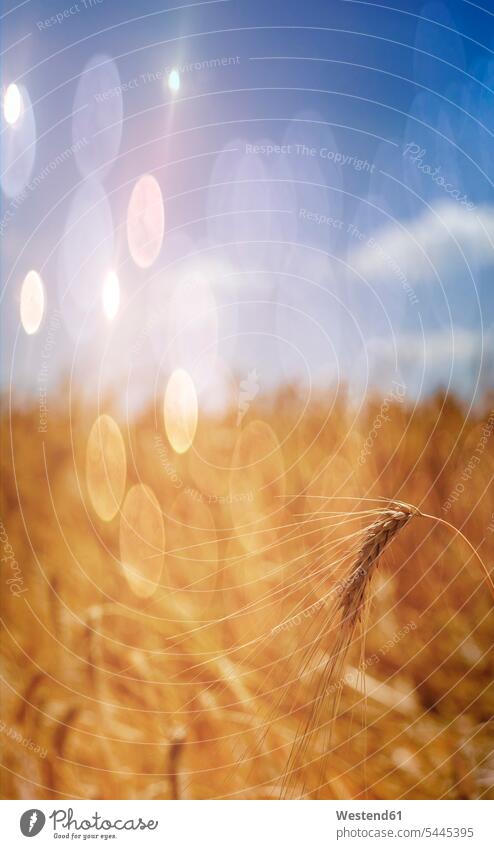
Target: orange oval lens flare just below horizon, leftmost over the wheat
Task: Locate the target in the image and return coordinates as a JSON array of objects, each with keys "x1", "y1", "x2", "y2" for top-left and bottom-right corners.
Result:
[{"x1": 86, "y1": 414, "x2": 127, "y2": 522}]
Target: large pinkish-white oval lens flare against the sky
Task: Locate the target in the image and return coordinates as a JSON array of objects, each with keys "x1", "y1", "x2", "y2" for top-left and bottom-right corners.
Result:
[{"x1": 127, "y1": 174, "x2": 165, "y2": 268}]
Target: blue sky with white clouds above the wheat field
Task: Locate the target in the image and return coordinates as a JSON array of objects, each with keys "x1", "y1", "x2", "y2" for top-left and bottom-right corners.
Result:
[{"x1": 1, "y1": 0, "x2": 494, "y2": 410}]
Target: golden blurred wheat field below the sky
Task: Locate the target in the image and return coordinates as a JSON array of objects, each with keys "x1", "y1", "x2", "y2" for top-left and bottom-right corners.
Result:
[{"x1": 1, "y1": 386, "x2": 494, "y2": 799}]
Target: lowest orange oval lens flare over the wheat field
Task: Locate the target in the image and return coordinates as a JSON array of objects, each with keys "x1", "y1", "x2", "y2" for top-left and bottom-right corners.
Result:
[{"x1": 120, "y1": 484, "x2": 165, "y2": 598}]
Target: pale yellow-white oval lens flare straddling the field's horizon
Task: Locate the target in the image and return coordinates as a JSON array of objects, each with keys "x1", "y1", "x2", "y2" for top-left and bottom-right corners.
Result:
[{"x1": 164, "y1": 369, "x2": 198, "y2": 454}]
